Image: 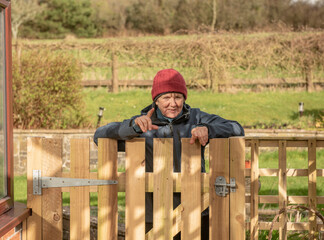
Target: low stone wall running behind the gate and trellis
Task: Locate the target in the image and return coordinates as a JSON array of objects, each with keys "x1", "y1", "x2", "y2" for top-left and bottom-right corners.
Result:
[{"x1": 14, "y1": 129, "x2": 324, "y2": 175}]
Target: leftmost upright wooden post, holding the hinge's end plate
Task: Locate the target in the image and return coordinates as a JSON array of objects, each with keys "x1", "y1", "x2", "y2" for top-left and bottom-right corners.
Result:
[{"x1": 27, "y1": 137, "x2": 42, "y2": 239}]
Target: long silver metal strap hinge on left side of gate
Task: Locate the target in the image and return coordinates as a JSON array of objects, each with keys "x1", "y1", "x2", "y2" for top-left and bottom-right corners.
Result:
[{"x1": 33, "y1": 170, "x2": 118, "y2": 195}]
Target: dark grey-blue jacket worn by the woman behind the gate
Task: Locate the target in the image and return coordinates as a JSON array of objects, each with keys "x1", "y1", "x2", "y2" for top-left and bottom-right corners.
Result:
[{"x1": 94, "y1": 103, "x2": 244, "y2": 222}]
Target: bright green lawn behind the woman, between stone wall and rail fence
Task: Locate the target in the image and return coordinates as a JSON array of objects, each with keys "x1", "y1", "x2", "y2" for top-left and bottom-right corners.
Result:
[{"x1": 83, "y1": 88, "x2": 324, "y2": 129}]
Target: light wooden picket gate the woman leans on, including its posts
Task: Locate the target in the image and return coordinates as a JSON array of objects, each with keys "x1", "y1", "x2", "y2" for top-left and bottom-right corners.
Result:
[{"x1": 27, "y1": 137, "x2": 245, "y2": 240}]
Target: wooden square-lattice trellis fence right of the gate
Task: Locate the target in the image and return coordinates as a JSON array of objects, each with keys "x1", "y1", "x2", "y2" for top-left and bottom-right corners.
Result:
[{"x1": 245, "y1": 137, "x2": 324, "y2": 239}]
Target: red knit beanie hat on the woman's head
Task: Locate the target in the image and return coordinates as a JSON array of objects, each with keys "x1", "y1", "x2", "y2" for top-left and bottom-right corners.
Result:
[{"x1": 151, "y1": 69, "x2": 187, "y2": 101}]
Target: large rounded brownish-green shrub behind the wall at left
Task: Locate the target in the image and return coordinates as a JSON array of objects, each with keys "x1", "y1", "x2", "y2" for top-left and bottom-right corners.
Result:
[{"x1": 13, "y1": 50, "x2": 87, "y2": 129}]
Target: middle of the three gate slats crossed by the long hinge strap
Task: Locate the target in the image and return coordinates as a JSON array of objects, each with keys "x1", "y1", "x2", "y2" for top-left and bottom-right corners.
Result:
[{"x1": 70, "y1": 139, "x2": 90, "y2": 240}]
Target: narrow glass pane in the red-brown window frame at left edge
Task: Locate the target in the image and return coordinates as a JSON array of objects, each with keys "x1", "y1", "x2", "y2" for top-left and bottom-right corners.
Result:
[{"x1": 0, "y1": 8, "x2": 7, "y2": 198}]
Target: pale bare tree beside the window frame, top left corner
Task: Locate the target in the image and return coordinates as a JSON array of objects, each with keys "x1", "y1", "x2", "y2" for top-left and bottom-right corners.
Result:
[{"x1": 11, "y1": 0, "x2": 45, "y2": 39}]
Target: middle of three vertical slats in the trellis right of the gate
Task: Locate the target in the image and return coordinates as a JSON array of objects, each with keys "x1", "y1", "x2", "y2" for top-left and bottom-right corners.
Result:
[{"x1": 279, "y1": 141, "x2": 287, "y2": 240}]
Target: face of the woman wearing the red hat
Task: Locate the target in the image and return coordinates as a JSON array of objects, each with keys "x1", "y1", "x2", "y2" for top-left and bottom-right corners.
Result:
[{"x1": 155, "y1": 93, "x2": 184, "y2": 118}]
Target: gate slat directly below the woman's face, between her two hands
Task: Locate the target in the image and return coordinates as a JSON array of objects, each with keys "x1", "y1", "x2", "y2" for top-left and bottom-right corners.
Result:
[{"x1": 153, "y1": 138, "x2": 173, "y2": 240}]
